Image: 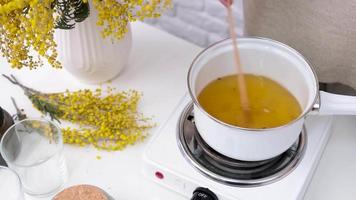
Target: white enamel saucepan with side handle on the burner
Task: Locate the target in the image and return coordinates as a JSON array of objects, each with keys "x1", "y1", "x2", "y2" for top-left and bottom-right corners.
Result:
[{"x1": 188, "y1": 38, "x2": 356, "y2": 161}]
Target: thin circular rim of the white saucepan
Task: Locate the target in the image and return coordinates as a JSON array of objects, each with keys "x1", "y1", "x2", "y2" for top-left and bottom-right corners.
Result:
[{"x1": 187, "y1": 37, "x2": 319, "y2": 132}]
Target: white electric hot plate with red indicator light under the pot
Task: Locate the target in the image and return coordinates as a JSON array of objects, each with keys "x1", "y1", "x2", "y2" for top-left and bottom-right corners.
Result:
[{"x1": 144, "y1": 95, "x2": 332, "y2": 200}]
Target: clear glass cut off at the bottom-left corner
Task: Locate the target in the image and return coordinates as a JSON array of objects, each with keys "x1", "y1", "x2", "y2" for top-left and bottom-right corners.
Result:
[{"x1": 0, "y1": 166, "x2": 25, "y2": 200}]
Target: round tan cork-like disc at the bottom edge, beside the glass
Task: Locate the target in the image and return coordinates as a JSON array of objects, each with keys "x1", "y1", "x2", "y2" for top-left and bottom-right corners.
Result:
[{"x1": 53, "y1": 185, "x2": 109, "y2": 200}]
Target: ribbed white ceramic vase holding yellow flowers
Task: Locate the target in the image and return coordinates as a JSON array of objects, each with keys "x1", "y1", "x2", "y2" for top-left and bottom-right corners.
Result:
[{"x1": 55, "y1": 7, "x2": 132, "y2": 83}]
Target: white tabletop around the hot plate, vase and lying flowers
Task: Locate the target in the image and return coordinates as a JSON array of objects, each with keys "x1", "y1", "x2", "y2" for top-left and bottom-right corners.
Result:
[{"x1": 0, "y1": 22, "x2": 356, "y2": 200}]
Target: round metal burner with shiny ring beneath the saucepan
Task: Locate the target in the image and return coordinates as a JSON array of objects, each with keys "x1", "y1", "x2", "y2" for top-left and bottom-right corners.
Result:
[{"x1": 177, "y1": 103, "x2": 307, "y2": 187}]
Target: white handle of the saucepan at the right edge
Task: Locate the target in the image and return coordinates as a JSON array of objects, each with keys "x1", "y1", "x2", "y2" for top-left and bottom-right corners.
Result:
[{"x1": 318, "y1": 91, "x2": 356, "y2": 115}]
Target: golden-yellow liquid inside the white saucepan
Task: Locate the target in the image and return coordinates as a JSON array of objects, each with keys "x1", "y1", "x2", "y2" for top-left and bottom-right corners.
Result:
[{"x1": 198, "y1": 74, "x2": 302, "y2": 129}]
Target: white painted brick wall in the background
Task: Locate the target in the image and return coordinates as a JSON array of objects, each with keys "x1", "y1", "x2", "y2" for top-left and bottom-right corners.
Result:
[{"x1": 146, "y1": 0, "x2": 243, "y2": 47}]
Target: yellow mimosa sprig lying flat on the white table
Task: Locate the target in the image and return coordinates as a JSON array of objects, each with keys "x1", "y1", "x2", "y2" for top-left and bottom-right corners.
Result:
[{"x1": 3, "y1": 75, "x2": 154, "y2": 150}]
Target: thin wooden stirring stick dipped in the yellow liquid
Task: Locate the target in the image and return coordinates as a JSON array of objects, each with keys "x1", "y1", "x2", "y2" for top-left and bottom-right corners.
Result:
[{"x1": 225, "y1": 0, "x2": 249, "y2": 114}]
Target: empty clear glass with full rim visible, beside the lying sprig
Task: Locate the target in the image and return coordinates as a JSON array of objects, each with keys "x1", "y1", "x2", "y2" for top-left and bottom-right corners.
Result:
[{"x1": 0, "y1": 119, "x2": 67, "y2": 196}]
